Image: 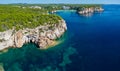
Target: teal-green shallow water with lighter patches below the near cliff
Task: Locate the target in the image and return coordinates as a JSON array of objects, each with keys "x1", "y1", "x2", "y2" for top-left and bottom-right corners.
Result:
[{"x1": 0, "y1": 31, "x2": 76, "y2": 71}]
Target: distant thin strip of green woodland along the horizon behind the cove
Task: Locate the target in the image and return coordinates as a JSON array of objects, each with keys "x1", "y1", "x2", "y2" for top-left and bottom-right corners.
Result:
[{"x1": 4, "y1": 4, "x2": 102, "y2": 12}]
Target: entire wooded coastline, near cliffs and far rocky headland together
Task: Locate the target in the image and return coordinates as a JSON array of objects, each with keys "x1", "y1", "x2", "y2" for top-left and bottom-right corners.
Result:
[{"x1": 0, "y1": 4, "x2": 104, "y2": 50}]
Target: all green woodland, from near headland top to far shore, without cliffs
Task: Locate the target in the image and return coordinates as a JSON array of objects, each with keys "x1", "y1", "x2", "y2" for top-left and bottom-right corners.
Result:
[{"x1": 0, "y1": 4, "x2": 101, "y2": 32}]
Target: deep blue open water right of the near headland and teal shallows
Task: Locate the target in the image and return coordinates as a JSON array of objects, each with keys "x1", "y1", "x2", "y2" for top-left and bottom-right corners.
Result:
[{"x1": 57, "y1": 5, "x2": 120, "y2": 71}]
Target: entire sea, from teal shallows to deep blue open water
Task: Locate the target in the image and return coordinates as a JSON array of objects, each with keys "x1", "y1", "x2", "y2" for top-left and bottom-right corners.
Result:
[{"x1": 0, "y1": 5, "x2": 120, "y2": 71}]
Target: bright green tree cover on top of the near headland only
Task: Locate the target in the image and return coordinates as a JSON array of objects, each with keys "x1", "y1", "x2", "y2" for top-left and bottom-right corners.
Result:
[{"x1": 0, "y1": 5, "x2": 61, "y2": 31}]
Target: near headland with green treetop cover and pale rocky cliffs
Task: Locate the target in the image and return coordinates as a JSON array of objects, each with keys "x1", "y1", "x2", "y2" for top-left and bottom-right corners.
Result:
[{"x1": 0, "y1": 5, "x2": 67, "y2": 50}]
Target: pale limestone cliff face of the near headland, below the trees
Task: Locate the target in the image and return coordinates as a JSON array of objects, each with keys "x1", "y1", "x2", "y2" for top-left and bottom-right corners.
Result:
[{"x1": 0, "y1": 20, "x2": 67, "y2": 50}]
